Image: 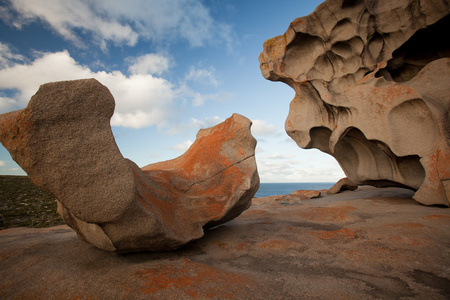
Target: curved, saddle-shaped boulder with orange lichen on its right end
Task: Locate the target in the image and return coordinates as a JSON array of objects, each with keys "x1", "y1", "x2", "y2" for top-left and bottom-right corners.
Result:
[{"x1": 0, "y1": 79, "x2": 259, "y2": 252}]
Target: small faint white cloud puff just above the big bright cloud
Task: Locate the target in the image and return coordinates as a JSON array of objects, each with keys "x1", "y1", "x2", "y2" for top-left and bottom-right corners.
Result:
[{"x1": 128, "y1": 53, "x2": 170, "y2": 75}]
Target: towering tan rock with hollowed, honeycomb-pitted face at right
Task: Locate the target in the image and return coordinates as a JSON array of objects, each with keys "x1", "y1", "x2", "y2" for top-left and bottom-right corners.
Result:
[{"x1": 260, "y1": 0, "x2": 450, "y2": 206}]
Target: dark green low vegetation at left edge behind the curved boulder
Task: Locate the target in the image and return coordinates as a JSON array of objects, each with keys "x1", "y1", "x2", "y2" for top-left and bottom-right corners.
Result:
[{"x1": 0, "y1": 176, "x2": 64, "y2": 229}]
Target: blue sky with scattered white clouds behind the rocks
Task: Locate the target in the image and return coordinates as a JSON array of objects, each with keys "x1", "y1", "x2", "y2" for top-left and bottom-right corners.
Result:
[{"x1": 0, "y1": 0, "x2": 345, "y2": 182}]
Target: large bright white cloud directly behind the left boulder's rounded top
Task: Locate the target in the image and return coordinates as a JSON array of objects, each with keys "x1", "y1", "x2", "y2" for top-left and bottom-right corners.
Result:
[{"x1": 0, "y1": 51, "x2": 176, "y2": 128}]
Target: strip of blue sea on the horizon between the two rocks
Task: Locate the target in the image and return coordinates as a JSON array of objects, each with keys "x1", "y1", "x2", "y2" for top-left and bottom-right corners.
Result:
[{"x1": 254, "y1": 182, "x2": 335, "y2": 198}]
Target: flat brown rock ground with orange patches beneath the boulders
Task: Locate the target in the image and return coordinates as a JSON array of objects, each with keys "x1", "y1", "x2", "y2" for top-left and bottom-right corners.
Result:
[{"x1": 0, "y1": 187, "x2": 450, "y2": 299}]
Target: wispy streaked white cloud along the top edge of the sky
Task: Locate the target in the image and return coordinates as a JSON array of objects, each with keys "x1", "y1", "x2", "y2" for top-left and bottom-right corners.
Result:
[{"x1": 3, "y1": 0, "x2": 233, "y2": 48}]
